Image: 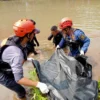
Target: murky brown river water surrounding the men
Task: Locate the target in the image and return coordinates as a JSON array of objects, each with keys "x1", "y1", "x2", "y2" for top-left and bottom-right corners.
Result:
[{"x1": 0, "y1": 0, "x2": 100, "y2": 100}]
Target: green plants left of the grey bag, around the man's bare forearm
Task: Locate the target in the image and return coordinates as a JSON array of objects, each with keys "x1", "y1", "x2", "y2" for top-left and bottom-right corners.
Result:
[{"x1": 29, "y1": 69, "x2": 48, "y2": 100}]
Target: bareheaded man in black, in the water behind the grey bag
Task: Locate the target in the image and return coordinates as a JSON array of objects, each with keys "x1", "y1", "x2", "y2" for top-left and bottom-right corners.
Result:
[{"x1": 48, "y1": 26, "x2": 62, "y2": 47}]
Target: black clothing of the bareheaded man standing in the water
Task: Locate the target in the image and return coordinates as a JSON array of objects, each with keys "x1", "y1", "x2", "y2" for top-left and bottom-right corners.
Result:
[{"x1": 48, "y1": 32, "x2": 63, "y2": 47}]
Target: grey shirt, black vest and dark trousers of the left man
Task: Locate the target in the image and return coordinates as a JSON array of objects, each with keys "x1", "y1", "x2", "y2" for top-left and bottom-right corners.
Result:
[{"x1": 0, "y1": 37, "x2": 27, "y2": 98}]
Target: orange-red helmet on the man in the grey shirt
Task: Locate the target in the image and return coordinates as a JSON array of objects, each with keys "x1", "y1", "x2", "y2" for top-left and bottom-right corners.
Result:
[{"x1": 13, "y1": 19, "x2": 35, "y2": 37}]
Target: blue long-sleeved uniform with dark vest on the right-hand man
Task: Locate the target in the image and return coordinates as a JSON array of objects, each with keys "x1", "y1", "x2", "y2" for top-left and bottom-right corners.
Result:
[{"x1": 59, "y1": 29, "x2": 90, "y2": 56}]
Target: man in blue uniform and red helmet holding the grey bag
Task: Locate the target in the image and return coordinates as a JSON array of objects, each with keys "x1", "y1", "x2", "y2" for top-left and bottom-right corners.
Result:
[{"x1": 57, "y1": 17, "x2": 90, "y2": 56}]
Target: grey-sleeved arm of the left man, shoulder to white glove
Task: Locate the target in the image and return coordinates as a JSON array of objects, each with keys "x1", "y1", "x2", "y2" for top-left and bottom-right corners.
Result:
[{"x1": 2, "y1": 46, "x2": 49, "y2": 93}]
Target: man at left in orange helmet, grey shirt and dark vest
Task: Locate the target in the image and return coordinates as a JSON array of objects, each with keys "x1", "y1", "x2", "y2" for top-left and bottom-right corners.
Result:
[{"x1": 0, "y1": 19, "x2": 49, "y2": 100}]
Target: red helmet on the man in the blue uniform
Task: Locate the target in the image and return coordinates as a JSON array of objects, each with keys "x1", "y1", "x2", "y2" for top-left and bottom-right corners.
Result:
[{"x1": 59, "y1": 17, "x2": 72, "y2": 29}]
